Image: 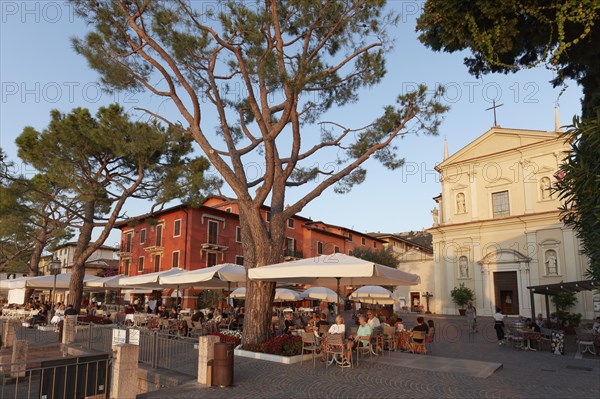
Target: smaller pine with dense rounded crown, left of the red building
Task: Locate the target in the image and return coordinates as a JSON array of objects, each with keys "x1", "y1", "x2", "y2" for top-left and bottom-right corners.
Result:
[{"x1": 16, "y1": 105, "x2": 216, "y2": 308}]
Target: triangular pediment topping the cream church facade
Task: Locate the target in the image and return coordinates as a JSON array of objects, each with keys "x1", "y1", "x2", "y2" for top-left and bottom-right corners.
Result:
[{"x1": 438, "y1": 126, "x2": 559, "y2": 169}]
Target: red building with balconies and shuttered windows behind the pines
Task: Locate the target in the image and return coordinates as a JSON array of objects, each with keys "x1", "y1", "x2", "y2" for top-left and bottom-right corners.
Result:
[{"x1": 116, "y1": 197, "x2": 384, "y2": 308}]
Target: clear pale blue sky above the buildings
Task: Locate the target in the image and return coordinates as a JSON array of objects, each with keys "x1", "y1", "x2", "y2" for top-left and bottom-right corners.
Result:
[{"x1": 0, "y1": 0, "x2": 582, "y2": 250}]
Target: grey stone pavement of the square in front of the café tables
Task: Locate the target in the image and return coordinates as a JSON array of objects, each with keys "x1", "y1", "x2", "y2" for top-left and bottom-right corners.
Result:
[{"x1": 138, "y1": 315, "x2": 600, "y2": 399}]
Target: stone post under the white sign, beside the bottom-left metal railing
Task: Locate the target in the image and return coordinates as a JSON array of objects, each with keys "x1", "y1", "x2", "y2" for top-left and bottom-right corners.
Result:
[{"x1": 110, "y1": 344, "x2": 140, "y2": 399}]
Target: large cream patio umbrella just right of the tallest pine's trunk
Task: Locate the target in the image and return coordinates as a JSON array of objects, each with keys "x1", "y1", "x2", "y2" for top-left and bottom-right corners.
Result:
[{"x1": 248, "y1": 253, "x2": 421, "y2": 308}]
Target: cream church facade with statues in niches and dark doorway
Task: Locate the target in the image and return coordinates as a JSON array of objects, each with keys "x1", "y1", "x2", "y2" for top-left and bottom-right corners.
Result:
[{"x1": 428, "y1": 126, "x2": 594, "y2": 318}]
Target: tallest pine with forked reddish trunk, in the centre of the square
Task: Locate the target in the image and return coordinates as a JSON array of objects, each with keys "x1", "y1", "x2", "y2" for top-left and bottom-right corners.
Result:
[{"x1": 73, "y1": 0, "x2": 446, "y2": 343}]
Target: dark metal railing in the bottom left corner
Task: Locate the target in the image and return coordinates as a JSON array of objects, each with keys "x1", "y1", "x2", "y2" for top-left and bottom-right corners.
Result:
[{"x1": 0, "y1": 354, "x2": 112, "y2": 399}]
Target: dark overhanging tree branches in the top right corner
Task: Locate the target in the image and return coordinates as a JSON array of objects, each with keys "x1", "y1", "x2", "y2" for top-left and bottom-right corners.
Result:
[{"x1": 417, "y1": 0, "x2": 600, "y2": 118}]
